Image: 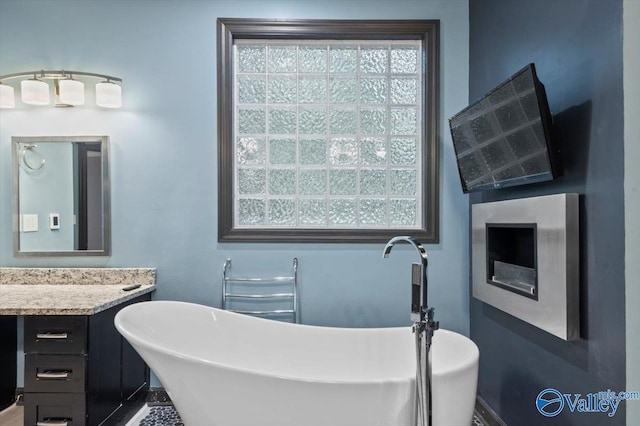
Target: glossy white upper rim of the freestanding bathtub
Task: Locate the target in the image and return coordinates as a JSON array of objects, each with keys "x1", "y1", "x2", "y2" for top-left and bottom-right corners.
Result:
[{"x1": 114, "y1": 300, "x2": 478, "y2": 385}]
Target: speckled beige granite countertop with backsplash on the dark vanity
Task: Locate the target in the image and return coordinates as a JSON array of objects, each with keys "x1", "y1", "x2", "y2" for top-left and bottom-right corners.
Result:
[{"x1": 0, "y1": 268, "x2": 156, "y2": 315}]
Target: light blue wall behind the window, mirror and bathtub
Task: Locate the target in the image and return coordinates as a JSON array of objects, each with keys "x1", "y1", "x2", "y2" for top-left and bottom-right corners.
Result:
[{"x1": 0, "y1": 0, "x2": 469, "y2": 384}]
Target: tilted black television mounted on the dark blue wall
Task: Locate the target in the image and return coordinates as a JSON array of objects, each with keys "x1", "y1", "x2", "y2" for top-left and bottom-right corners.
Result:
[{"x1": 449, "y1": 64, "x2": 557, "y2": 192}]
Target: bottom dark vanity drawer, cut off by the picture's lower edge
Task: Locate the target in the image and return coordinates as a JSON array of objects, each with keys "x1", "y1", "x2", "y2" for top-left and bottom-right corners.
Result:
[{"x1": 24, "y1": 393, "x2": 86, "y2": 426}]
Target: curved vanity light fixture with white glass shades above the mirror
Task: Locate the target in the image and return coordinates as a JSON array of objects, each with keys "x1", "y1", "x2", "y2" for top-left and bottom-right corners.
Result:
[{"x1": 0, "y1": 70, "x2": 122, "y2": 108}]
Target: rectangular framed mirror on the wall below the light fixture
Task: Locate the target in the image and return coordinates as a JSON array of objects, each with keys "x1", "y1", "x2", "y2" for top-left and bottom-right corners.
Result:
[{"x1": 11, "y1": 136, "x2": 111, "y2": 257}]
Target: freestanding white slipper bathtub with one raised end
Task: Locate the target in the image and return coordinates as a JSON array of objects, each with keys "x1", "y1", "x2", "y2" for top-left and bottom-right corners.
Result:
[{"x1": 115, "y1": 301, "x2": 479, "y2": 426}]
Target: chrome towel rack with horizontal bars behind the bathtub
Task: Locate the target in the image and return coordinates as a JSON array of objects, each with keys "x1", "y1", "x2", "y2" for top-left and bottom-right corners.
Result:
[{"x1": 222, "y1": 257, "x2": 299, "y2": 323}]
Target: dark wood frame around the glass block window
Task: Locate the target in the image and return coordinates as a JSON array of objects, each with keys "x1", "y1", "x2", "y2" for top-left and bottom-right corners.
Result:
[{"x1": 217, "y1": 18, "x2": 440, "y2": 243}]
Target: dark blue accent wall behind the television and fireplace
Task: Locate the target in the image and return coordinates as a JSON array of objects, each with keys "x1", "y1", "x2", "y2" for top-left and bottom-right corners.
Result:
[{"x1": 469, "y1": 0, "x2": 637, "y2": 425}]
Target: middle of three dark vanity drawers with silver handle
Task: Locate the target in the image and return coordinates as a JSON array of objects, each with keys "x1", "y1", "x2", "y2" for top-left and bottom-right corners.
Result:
[{"x1": 24, "y1": 354, "x2": 86, "y2": 392}]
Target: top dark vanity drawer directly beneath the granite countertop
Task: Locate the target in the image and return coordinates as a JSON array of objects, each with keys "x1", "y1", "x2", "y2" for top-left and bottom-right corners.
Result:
[{"x1": 24, "y1": 315, "x2": 87, "y2": 354}]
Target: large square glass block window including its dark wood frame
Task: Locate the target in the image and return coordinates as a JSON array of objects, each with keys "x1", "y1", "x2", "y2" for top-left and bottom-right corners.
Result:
[{"x1": 219, "y1": 20, "x2": 437, "y2": 241}]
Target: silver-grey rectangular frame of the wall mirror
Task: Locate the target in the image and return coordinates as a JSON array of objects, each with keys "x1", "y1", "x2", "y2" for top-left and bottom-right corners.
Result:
[{"x1": 11, "y1": 136, "x2": 111, "y2": 257}]
